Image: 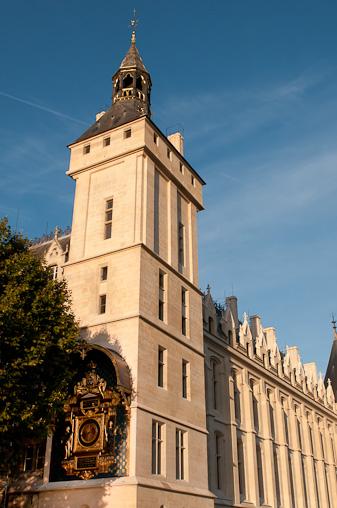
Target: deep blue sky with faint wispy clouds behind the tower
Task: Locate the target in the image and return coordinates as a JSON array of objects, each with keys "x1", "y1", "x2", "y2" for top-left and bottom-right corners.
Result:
[{"x1": 0, "y1": 0, "x2": 337, "y2": 371}]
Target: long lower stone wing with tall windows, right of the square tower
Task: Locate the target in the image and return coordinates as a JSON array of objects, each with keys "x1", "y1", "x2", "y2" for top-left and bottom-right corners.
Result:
[{"x1": 203, "y1": 291, "x2": 337, "y2": 508}]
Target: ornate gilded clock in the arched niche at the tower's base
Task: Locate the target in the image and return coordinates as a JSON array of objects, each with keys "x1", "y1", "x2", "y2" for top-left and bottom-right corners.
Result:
[{"x1": 62, "y1": 362, "x2": 129, "y2": 480}]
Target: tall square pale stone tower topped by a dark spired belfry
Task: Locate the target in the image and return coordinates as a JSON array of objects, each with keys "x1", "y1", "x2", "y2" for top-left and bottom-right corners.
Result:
[{"x1": 39, "y1": 33, "x2": 214, "y2": 508}]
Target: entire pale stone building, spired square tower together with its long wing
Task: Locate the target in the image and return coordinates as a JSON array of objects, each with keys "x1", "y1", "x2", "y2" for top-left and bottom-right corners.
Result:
[{"x1": 7, "y1": 33, "x2": 337, "y2": 508}]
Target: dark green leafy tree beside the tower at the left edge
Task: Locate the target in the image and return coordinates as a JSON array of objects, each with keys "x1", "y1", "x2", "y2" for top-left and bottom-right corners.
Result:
[{"x1": 0, "y1": 219, "x2": 80, "y2": 470}]
